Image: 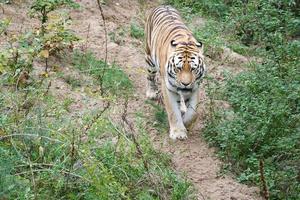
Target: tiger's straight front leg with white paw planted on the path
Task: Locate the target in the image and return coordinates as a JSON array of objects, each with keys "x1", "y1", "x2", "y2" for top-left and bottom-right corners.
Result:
[{"x1": 162, "y1": 81, "x2": 187, "y2": 140}]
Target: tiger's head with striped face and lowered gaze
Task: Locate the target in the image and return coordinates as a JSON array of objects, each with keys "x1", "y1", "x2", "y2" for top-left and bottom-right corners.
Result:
[{"x1": 167, "y1": 40, "x2": 205, "y2": 90}]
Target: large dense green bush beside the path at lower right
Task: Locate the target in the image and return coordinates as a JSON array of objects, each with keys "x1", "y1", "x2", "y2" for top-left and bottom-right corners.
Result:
[{"x1": 205, "y1": 43, "x2": 300, "y2": 199}]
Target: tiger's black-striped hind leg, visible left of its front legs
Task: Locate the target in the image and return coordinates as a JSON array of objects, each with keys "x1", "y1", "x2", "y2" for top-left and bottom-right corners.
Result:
[{"x1": 146, "y1": 55, "x2": 158, "y2": 99}]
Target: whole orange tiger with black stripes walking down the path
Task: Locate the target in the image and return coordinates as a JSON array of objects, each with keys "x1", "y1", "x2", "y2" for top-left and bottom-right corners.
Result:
[{"x1": 145, "y1": 5, "x2": 206, "y2": 140}]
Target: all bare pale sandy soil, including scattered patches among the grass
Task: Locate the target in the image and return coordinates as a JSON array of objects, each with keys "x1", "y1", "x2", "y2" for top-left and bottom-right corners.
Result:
[{"x1": 0, "y1": 0, "x2": 262, "y2": 200}]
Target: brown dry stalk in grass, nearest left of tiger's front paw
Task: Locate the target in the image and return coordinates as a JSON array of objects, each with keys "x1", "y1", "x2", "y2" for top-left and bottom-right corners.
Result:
[{"x1": 122, "y1": 98, "x2": 149, "y2": 172}]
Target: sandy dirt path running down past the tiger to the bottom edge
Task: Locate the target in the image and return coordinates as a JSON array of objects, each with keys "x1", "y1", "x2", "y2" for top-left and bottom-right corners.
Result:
[{"x1": 67, "y1": 0, "x2": 261, "y2": 200}]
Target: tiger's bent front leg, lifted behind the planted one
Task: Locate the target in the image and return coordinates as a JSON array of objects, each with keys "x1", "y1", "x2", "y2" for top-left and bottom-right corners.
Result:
[{"x1": 183, "y1": 91, "x2": 199, "y2": 128}]
